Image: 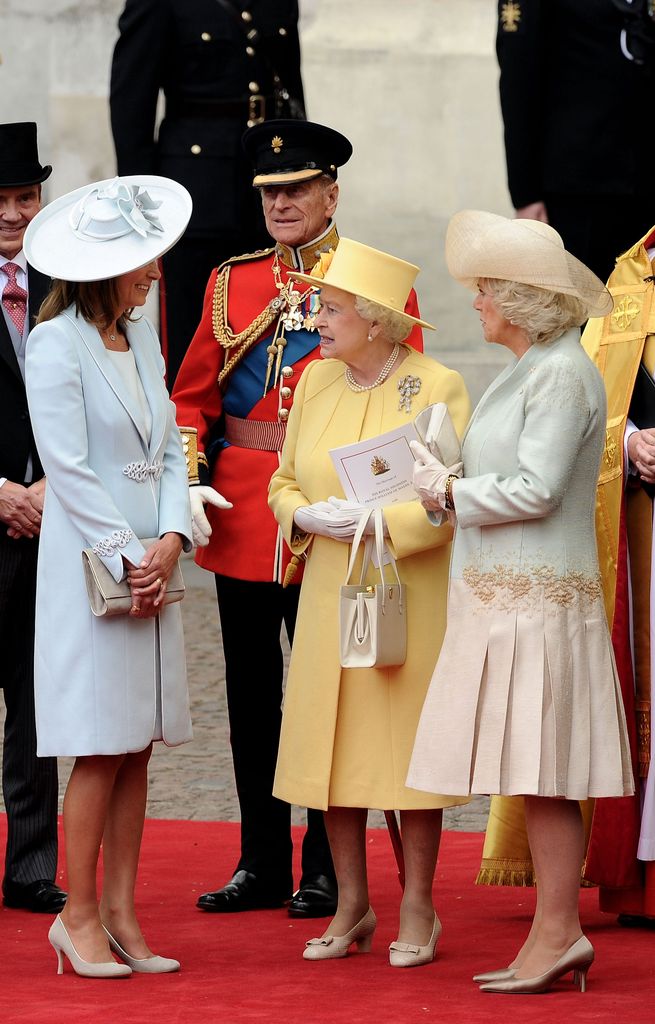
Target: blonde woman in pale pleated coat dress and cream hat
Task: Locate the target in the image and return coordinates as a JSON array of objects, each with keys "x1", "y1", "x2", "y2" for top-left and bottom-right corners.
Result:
[{"x1": 407, "y1": 211, "x2": 632, "y2": 993}]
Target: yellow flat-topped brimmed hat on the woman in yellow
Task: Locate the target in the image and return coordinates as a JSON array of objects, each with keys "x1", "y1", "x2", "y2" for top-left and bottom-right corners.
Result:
[{"x1": 289, "y1": 239, "x2": 435, "y2": 331}]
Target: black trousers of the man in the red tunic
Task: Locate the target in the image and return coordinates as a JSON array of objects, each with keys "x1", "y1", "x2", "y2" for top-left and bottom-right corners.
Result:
[{"x1": 216, "y1": 575, "x2": 335, "y2": 896}]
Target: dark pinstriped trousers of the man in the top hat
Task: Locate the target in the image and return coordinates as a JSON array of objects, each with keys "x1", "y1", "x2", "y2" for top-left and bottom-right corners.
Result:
[{"x1": 0, "y1": 526, "x2": 57, "y2": 885}]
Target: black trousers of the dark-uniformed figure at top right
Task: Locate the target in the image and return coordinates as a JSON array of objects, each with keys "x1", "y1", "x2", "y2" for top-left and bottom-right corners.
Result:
[{"x1": 544, "y1": 193, "x2": 655, "y2": 281}]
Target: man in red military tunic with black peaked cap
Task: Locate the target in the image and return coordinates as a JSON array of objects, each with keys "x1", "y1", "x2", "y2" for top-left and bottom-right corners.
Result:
[{"x1": 173, "y1": 120, "x2": 422, "y2": 916}]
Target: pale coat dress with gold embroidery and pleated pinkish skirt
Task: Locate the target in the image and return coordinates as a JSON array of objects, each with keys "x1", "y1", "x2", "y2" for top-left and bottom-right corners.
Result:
[{"x1": 407, "y1": 331, "x2": 632, "y2": 800}]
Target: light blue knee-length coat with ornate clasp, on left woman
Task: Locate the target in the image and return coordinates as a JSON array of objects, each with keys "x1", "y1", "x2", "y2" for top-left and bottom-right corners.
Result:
[{"x1": 26, "y1": 307, "x2": 191, "y2": 757}]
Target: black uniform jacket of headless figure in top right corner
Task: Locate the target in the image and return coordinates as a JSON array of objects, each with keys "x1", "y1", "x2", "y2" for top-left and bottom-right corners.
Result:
[{"x1": 496, "y1": 0, "x2": 655, "y2": 209}]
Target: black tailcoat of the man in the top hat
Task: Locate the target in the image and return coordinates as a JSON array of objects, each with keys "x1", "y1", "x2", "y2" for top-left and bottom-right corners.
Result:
[{"x1": 0, "y1": 266, "x2": 50, "y2": 483}]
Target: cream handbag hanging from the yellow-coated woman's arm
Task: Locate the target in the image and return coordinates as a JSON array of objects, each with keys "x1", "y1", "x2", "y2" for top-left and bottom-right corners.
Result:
[{"x1": 339, "y1": 509, "x2": 407, "y2": 669}]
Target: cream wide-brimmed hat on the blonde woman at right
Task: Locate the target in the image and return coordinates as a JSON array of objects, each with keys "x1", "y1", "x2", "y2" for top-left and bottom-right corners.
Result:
[{"x1": 446, "y1": 210, "x2": 612, "y2": 316}]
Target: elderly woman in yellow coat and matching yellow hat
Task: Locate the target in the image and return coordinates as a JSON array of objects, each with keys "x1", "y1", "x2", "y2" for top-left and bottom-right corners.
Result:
[{"x1": 269, "y1": 239, "x2": 469, "y2": 967}]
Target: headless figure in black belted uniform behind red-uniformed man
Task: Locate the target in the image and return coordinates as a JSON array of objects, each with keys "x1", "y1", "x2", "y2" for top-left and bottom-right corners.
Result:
[{"x1": 110, "y1": 0, "x2": 305, "y2": 388}]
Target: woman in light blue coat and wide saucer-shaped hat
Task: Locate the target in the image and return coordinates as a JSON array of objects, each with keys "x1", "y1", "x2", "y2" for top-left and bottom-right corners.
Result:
[{"x1": 25, "y1": 177, "x2": 191, "y2": 977}]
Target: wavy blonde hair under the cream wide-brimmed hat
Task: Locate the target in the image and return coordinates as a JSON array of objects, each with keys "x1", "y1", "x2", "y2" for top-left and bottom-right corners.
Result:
[{"x1": 479, "y1": 278, "x2": 587, "y2": 345}]
